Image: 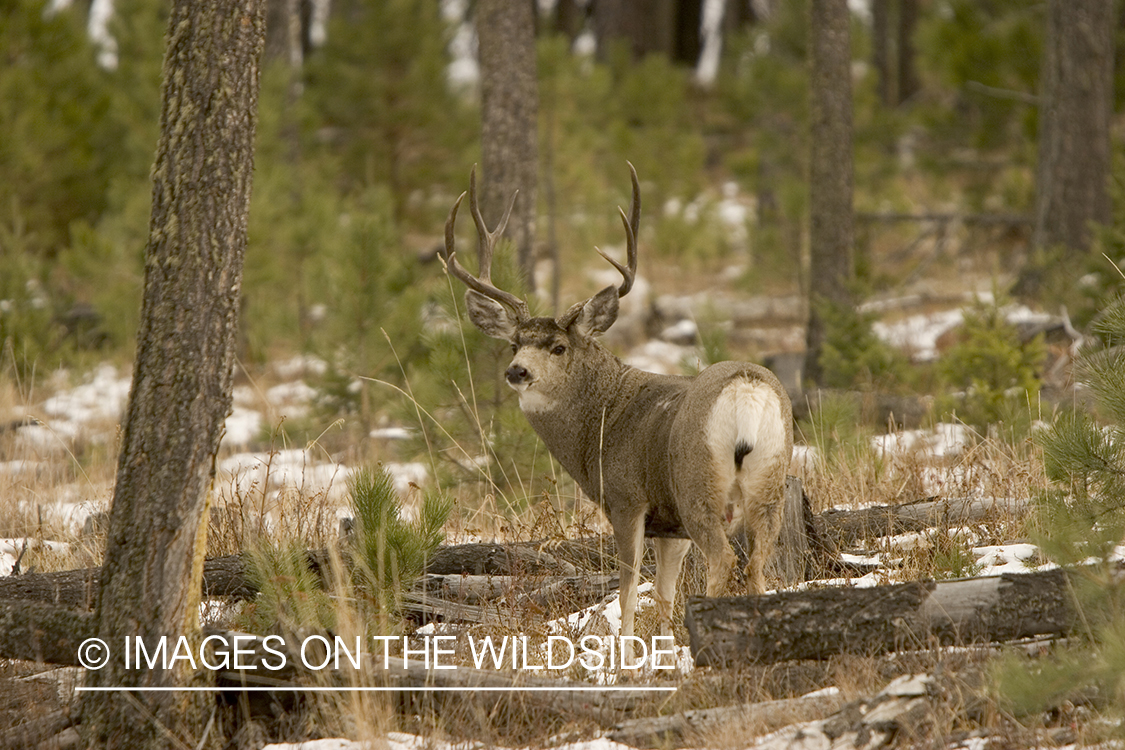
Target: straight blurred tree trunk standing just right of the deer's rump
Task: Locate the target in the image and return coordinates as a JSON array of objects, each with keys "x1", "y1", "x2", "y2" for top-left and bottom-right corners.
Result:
[{"x1": 804, "y1": 0, "x2": 855, "y2": 385}]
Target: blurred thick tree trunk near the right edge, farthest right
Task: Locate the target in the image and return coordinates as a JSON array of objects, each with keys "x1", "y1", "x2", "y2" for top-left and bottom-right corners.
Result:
[{"x1": 1030, "y1": 0, "x2": 1114, "y2": 295}]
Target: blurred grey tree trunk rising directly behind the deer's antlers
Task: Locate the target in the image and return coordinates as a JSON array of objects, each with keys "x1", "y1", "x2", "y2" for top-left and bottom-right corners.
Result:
[{"x1": 476, "y1": 0, "x2": 539, "y2": 290}]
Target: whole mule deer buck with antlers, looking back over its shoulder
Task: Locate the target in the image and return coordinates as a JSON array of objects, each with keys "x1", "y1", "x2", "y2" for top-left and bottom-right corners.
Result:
[{"x1": 442, "y1": 164, "x2": 793, "y2": 660}]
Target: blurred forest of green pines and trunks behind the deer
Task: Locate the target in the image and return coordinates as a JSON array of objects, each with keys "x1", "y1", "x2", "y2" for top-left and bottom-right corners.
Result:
[{"x1": 0, "y1": 0, "x2": 1125, "y2": 443}]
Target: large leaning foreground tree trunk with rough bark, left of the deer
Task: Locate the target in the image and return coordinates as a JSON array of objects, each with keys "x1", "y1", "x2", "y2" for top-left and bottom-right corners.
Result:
[{"x1": 82, "y1": 0, "x2": 264, "y2": 749}]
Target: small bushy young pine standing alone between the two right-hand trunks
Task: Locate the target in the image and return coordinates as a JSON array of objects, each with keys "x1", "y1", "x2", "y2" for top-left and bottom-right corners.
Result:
[{"x1": 937, "y1": 299, "x2": 1046, "y2": 439}]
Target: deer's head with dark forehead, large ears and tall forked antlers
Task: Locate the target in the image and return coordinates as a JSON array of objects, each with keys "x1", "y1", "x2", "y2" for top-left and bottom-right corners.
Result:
[{"x1": 442, "y1": 164, "x2": 640, "y2": 412}]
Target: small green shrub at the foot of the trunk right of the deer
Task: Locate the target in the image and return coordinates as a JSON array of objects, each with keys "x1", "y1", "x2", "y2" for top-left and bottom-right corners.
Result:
[{"x1": 818, "y1": 300, "x2": 908, "y2": 390}]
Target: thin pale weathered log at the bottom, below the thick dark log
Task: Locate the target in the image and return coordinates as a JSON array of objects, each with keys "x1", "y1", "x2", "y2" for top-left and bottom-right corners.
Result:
[{"x1": 606, "y1": 693, "x2": 844, "y2": 749}]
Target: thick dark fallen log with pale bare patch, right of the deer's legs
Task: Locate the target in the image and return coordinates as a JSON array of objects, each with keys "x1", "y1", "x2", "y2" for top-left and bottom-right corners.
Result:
[{"x1": 686, "y1": 570, "x2": 1076, "y2": 667}]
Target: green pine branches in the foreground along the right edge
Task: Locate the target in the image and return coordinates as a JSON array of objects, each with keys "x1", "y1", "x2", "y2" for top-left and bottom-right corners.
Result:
[{"x1": 997, "y1": 298, "x2": 1125, "y2": 716}]
